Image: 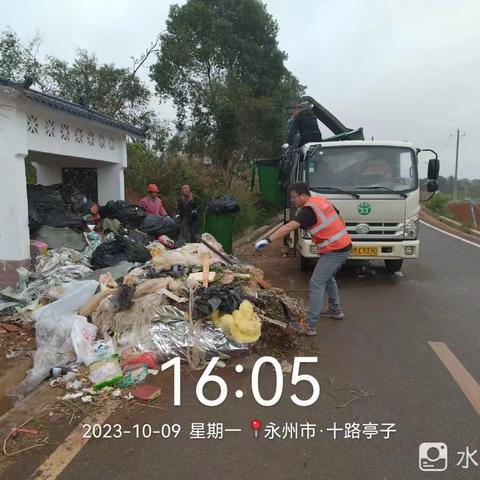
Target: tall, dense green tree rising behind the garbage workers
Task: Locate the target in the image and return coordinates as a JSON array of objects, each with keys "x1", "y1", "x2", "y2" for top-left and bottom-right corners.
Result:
[{"x1": 151, "y1": 0, "x2": 303, "y2": 167}]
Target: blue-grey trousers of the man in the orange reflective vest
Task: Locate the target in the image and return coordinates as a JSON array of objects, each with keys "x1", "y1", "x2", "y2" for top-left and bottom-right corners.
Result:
[{"x1": 307, "y1": 252, "x2": 350, "y2": 327}]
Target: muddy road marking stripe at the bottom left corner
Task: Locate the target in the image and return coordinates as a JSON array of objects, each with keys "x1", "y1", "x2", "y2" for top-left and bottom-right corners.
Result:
[{"x1": 30, "y1": 408, "x2": 112, "y2": 480}]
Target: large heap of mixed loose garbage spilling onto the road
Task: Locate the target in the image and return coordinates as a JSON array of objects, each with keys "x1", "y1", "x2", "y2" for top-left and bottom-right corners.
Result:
[{"x1": 0, "y1": 229, "x2": 303, "y2": 403}]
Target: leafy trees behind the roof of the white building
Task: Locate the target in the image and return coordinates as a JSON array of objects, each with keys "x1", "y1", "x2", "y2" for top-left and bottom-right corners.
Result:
[{"x1": 0, "y1": 30, "x2": 169, "y2": 151}]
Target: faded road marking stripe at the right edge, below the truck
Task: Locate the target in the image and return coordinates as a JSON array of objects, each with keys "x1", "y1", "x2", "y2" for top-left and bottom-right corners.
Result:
[{"x1": 428, "y1": 342, "x2": 480, "y2": 415}]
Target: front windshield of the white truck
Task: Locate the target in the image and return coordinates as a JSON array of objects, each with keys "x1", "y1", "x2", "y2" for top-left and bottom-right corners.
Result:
[{"x1": 305, "y1": 146, "x2": 417, "y2": 193}]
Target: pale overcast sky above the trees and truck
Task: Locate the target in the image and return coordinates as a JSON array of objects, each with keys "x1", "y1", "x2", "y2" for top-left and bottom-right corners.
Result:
[{"x1": 0, "y1": 0, "x2": 480, "y2": 178}]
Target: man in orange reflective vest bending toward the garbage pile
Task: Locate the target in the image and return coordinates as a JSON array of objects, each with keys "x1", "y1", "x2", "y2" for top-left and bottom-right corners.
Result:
[{"x1": 255, "y1": 182, "x2": 352, "y2": 336}]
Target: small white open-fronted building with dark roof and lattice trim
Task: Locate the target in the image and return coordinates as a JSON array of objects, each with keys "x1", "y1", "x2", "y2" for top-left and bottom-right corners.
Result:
[{"x1": 0, "y1": 78, "x2": 144, "y2": 288}]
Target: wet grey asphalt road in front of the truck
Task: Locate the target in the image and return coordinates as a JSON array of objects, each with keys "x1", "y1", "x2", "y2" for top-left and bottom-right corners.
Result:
[{"x1": 5, "y1": 222, "x2": 480, "y2": 480}]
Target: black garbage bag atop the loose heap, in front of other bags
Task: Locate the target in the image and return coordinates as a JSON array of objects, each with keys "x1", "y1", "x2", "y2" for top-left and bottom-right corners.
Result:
[{"x1": 91, "y1": 237, "x2": 152, "y2": 268}]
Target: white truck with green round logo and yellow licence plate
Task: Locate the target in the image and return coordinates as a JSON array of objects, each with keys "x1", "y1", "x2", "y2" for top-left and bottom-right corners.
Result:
[{"x1": 285, "y1": 97, "x2": 439, "y2": 272}]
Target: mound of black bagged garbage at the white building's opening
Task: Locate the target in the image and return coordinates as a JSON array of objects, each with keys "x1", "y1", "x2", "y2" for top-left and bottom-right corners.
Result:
[{"x1": 27, "y1": 184, "x2": 183, "y2": 268}]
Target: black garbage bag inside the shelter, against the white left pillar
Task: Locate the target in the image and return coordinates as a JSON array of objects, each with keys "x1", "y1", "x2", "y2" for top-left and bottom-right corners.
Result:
[{"x1": 27, "y1": 185, "x2": 88, "y2": 233}]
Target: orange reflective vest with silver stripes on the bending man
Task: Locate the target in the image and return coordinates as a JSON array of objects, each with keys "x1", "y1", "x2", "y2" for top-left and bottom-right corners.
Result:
[{"x1": 304, "y1": 197, "x2": 352, "y2": 255}]
